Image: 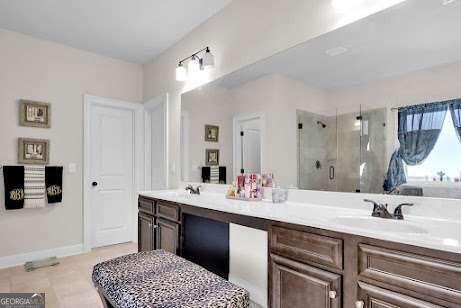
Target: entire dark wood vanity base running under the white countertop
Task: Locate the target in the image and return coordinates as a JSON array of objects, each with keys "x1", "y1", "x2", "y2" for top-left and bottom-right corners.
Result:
[{"x1": 138, "y1": 197, "x2": 461, "y2": 308}]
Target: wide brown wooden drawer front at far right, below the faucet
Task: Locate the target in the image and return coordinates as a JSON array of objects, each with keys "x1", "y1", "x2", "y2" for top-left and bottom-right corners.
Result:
[{"x1": 359, "y1": 244, "x2": 461, "y2": 305}]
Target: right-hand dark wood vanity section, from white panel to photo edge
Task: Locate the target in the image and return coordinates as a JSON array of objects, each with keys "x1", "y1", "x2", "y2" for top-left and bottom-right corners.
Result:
[{"x1": 269, "y1": 224, "x2": 461, "y2": 308}]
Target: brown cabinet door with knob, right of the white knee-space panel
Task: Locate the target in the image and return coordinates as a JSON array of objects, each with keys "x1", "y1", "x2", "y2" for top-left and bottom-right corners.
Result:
[{"x1": 269, "y1": 255, "x2": 341, "y2": 308}]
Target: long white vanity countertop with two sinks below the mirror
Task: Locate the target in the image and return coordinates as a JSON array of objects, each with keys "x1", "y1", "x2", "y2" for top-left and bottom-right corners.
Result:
[{"x1": 139, "y1": 190, "x2": 461, "y2": 253}]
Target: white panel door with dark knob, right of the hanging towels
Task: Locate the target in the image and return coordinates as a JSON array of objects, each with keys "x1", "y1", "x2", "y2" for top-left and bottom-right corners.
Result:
[{"x1": 90, "y1": 105, "x2": 134, "y2": 247}]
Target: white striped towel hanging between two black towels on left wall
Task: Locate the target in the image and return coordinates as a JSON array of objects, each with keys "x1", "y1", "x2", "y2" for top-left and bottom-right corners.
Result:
[{"x1": 24, "y1": 165, "x2": 46, "y2": 209}]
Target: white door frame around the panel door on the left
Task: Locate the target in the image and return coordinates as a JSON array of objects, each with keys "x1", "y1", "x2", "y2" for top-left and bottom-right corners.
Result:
[{"x1": 82, "y1": 95, "x2": 144, "y2": 252}]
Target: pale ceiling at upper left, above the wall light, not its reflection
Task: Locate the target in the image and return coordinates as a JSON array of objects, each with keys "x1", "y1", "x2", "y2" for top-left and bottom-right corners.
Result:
[{"x1": 0, "y1": 0, "x2": 231, "y2": 63}]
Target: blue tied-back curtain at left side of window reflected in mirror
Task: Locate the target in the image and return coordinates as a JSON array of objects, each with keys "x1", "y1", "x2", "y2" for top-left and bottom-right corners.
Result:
[{"x1": 384, "y1": 102, "x2": 448, "y2": 191}]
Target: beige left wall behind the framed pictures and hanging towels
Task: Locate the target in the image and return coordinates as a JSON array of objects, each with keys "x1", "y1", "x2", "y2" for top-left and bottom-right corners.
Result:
[{"x1": 0, "y1": 30, "x2": 142, "y2": 257}]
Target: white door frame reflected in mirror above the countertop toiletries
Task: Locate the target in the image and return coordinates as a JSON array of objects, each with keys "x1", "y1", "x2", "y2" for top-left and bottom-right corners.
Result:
[{"x1": 232, "y1": 113, "x2": 266, "y2": 178}]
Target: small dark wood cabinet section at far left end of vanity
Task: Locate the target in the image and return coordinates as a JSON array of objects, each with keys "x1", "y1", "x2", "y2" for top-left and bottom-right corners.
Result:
[{"x1": 138, "y1": 198, "x2": 181, "y2": 254}]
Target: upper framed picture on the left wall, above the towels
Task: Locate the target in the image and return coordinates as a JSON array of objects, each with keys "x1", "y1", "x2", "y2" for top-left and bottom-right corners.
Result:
[{"x1": 19, "y1": 99, "x2": 51, "y2": 128}]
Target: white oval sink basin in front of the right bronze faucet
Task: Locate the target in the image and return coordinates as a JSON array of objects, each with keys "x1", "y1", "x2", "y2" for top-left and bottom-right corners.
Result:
[{"x1": 331, "y1": 216, "x2": 428, "y2": 234}]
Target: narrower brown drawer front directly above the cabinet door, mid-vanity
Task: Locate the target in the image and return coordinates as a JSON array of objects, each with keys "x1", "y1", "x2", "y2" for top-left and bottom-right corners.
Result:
[{"x1": 270, "y1": 227, "x2": 343, "y2": 270}]
